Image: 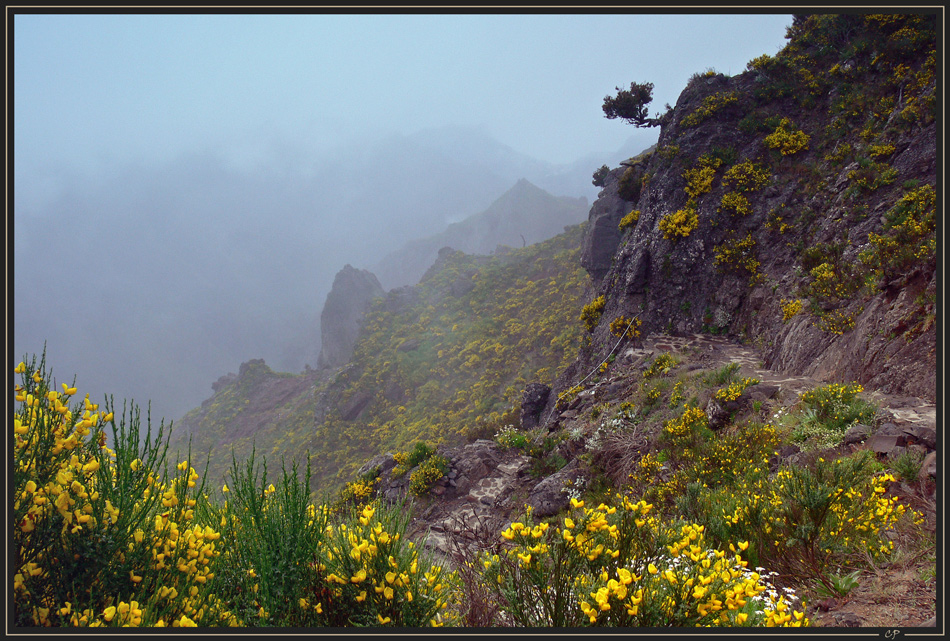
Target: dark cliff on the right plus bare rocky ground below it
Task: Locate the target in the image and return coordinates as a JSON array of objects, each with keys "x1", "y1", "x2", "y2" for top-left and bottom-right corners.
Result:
[{"x1": 346, "y1": 16, "x2": 942, "y2": 627}]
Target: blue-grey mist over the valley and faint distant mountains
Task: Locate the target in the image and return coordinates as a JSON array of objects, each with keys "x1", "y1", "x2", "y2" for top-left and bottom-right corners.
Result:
[{"x1": 14, "y1": 127, "x2": 650, "y2": 420}]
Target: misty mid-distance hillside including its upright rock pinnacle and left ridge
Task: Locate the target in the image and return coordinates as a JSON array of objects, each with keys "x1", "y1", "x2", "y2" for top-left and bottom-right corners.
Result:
[{"x1": 174, "y1": 225, "x2": 589, "y2": 492}]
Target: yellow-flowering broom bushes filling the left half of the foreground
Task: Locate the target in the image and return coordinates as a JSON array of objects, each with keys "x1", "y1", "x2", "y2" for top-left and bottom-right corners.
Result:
[{"x1": 13, "y1": 359, "x2": 456, "y2": 627}]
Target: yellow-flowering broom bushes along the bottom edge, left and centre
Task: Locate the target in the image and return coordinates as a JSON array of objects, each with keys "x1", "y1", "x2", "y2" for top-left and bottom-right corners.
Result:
[{"x1": 12, "y1": 359, "x2": 824, "y2": 628}]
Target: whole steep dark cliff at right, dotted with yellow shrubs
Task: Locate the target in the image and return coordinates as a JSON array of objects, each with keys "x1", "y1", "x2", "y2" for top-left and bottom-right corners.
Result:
[{"x1": 563, "y1": 16, "x2": 937, "y2": 424}]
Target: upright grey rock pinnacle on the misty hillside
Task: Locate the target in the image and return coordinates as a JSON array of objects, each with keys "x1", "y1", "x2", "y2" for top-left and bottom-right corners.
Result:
[{"x1": 317, "y1": 265, "x2": 385, "y2": 368}]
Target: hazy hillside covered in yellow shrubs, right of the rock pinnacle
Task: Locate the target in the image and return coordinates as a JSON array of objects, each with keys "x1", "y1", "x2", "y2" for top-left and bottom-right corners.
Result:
[{"x1": 311, "y1": 226, "x2": 588, "y2": 490}]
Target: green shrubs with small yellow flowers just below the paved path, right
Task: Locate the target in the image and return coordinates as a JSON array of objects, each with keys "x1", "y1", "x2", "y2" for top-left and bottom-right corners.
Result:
[{"x1": 616, "y1": 356, "x2": 919, "y2": 600}]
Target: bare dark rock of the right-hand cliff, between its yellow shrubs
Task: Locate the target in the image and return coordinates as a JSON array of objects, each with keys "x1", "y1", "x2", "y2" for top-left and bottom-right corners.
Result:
[{"x1": 572, "y1": 63, "x2": 936, "y2": 400}]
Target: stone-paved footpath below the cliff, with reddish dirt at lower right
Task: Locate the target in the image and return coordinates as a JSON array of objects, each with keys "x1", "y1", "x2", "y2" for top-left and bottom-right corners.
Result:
[{"x1": 411, "y1": 334, "x2": 937, "y2": 630}]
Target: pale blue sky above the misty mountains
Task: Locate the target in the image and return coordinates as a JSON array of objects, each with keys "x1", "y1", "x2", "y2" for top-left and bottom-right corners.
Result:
[{"x1": 13, "y1": 14, "x2": 791, "y2": 173}]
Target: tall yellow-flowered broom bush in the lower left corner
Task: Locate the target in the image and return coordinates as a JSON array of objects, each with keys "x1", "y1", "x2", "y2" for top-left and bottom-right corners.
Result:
[{"x1": 12, "y1": 358, "x2": 236, "y2": 627}]
